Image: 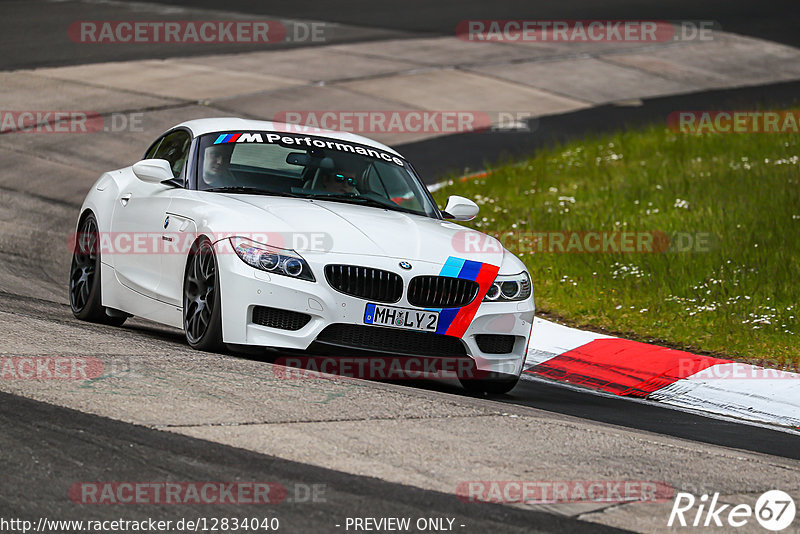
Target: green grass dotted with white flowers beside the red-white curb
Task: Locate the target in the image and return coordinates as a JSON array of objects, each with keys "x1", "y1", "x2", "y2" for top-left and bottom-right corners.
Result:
[{"x1": 435, "y1": 119, "x2": 800, "y2": 366}]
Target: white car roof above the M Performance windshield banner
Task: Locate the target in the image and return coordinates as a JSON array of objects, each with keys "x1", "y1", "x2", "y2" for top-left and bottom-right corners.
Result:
[{"x1": 174, "y1": 117, "x2": 402, "y2": 157}]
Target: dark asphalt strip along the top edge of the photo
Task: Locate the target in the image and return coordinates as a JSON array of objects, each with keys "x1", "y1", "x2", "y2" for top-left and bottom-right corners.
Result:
[{"x1": 0, "y1": 0, "x2": 800, "y2": 70}]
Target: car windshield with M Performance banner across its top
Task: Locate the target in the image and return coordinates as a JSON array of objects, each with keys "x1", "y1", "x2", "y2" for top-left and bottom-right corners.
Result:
[{"x1": 197, "y1": 132, "x2": 438, "y2": 217}]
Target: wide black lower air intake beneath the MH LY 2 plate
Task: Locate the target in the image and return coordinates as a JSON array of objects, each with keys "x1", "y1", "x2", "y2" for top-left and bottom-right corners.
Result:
[{"x1": 310, "y1": 324, "x2": 467, "y2": 358}]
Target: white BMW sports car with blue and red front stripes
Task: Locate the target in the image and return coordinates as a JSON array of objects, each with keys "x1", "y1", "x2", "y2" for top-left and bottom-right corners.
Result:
[{"x1": 69, "y1": 118, "x2": 534, "y2": 392}]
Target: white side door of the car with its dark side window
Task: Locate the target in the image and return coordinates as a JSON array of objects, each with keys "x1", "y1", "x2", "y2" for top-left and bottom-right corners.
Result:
[{"x1": 111, "y1": 130, "x2": 191, "y2": 300}]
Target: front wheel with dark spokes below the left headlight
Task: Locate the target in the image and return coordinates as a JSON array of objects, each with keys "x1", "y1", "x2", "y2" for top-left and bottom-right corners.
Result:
[{"x1": 183, "y1": 237, "x2": 225, "y2": 352}]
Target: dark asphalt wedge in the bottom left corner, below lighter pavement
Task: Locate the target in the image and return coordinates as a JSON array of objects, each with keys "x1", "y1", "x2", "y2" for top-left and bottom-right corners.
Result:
[{"x1": 0, "y1": 393, "x2": 621, "y2": 533}]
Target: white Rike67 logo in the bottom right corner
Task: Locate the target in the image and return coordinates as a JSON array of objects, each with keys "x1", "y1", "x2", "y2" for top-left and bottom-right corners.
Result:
[{"x1": 667, "y1": 490, "x2": 796, "y2": 532}]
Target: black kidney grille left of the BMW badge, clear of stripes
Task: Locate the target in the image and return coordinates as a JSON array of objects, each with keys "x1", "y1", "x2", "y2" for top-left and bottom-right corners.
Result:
[{"x1": 325, "y1": 265, "x2": 403, "y2": 302}]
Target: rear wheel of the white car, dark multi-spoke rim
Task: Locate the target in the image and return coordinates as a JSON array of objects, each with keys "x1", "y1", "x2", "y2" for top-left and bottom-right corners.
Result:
[{"x1": 69, "y1": 213, "x2": 129, "y2": 326}]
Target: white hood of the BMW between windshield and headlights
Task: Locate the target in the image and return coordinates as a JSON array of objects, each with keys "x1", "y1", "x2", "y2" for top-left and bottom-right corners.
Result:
[{"x1": 209, "y1": 195, "x2": 503, "y2": 266}]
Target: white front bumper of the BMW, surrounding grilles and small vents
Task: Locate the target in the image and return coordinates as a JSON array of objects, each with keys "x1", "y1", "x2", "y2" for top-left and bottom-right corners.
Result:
[{"x1": 215, "y1": 243, "x2": 534, "y2": 375}]
